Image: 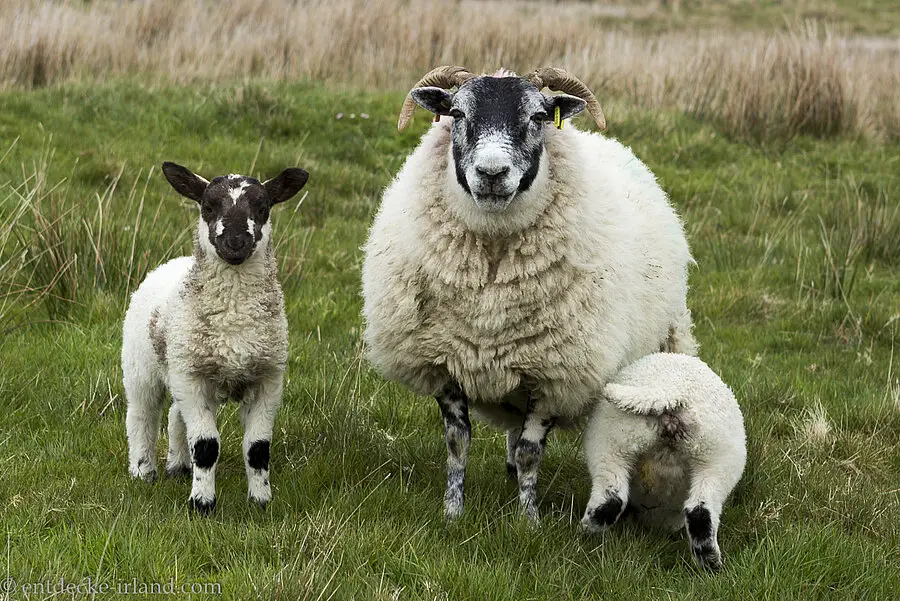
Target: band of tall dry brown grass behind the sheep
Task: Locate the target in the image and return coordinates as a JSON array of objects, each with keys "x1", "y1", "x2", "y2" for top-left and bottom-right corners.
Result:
[{"x1": 0, "y1": 0, "x2": 900, "y2": 139}]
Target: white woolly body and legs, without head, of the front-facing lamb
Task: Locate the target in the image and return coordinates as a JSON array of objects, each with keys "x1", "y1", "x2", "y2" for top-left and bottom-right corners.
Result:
[{"x1": 122, "y1": 219, "x2": 288, "y2": 508}]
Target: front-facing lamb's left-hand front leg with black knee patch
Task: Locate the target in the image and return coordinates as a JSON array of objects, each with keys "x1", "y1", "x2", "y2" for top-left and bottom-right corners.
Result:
[{"x1": 170, "y1": 375, "x2": 219, "y2": 514}]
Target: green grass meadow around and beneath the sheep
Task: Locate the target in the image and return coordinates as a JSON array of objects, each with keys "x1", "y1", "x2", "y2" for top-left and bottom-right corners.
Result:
[{"x1": 0, "y1": 81, "x2": 900, "y2": 600}]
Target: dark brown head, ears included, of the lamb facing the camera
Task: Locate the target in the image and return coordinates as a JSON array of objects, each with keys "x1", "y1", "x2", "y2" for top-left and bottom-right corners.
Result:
[{"x1": 163, "y1": 163, "x2": 309, "y2": 265}]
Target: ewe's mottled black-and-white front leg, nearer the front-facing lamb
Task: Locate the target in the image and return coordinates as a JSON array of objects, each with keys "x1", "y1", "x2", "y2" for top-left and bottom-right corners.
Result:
[{"x1": 436, "y1": 385, "x2": 472, "y2": 520}]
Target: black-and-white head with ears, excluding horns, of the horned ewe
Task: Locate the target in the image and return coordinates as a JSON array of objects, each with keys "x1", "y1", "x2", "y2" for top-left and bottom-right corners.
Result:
[{"x1": 410, "y1": 76, "x2": 585, "y2": 212}]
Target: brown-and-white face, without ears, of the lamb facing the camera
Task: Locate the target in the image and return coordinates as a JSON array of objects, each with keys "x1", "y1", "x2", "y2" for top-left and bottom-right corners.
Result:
[{"x1": 200, "y1": 175, "x2": 272, "y2": 265}]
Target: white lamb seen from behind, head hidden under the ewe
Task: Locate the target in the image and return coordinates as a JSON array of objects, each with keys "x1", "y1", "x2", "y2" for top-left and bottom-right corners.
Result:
[{"x1": 581, "y1": 353, "x2": 747, "y2": 569}]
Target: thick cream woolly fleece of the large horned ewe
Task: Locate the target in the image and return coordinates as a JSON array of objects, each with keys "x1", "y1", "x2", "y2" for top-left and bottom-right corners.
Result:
[{"x1": 363, "y1": 118, "x2": 696, "y2": 428}]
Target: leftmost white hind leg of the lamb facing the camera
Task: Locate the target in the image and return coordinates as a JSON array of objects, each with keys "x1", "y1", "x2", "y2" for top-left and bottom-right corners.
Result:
[{"x1": 124, "y1": 376, "x2": 165, "y2": 482}]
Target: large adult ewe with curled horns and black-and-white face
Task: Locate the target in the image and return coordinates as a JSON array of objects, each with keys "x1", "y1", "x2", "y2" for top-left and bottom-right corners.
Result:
[{"x1": 362, "y1": 67, "x2": 696, "y2": 519}]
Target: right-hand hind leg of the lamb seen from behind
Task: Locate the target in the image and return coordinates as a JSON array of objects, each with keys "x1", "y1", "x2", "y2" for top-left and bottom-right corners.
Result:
[{"x1": 684, "y1": 450, "x2": 743, "y2": 570}]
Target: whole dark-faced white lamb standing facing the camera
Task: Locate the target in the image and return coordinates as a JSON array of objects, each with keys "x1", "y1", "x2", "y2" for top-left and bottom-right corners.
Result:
[{"x1": 122, "y1": 163, "x2": 309, "y2": 513}]
